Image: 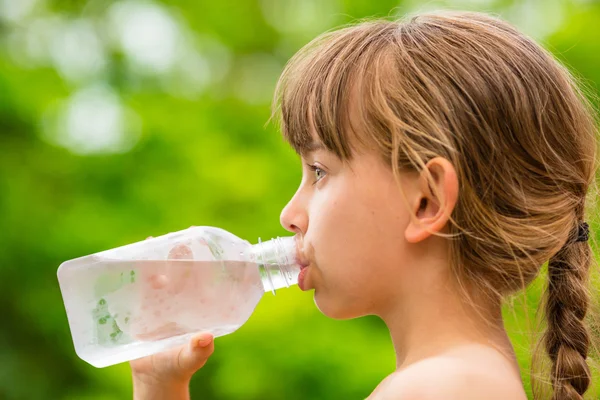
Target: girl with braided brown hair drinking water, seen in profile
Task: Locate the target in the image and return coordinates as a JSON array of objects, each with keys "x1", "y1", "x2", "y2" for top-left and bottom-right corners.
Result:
[{"x1": 126, "y1": 13, "x2": 597, "y2": 400}]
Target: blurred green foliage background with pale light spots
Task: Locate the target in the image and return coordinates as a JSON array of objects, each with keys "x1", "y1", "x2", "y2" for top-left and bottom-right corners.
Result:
[{"x1": 0, "y1": 0, "x2": 600, "y2": 400}]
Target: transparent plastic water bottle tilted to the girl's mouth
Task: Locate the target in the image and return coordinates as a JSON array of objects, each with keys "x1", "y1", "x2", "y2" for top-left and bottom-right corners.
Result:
[{"x1": 57, "y1": 227, "x2": 301, "y2": 368}]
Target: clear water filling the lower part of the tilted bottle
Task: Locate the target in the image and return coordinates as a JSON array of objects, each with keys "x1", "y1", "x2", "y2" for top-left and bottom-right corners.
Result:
[{"x1": 59, "y1": 256, "x2": 264, "y2": 367}]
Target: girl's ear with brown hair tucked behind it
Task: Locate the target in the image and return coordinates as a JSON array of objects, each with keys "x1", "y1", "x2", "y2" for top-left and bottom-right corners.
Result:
[{"x1": 404, "y1": 157, "x2": 458, "y2": 243}]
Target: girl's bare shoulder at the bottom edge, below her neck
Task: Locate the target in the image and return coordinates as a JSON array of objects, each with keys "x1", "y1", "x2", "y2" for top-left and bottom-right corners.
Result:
[{"x1": 369, "y1": 349, "x2": 527, "y2": 400}]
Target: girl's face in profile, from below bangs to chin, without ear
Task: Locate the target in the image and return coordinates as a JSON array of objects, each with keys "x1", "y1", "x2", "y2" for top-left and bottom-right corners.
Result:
[{"x1": 281, "y1": 144, "x2": 418, "y2": 318}]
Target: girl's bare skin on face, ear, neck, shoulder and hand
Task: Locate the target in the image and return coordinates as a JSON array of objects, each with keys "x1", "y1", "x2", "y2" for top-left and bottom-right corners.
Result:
[{"x1": 131, "y1": 141, "x2": 526, "y2": 400}]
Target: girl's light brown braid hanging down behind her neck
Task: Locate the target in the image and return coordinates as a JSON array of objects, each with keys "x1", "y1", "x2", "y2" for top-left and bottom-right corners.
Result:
[{"x1": 544, "y1": 223, "x2": 591, "y2": 400}]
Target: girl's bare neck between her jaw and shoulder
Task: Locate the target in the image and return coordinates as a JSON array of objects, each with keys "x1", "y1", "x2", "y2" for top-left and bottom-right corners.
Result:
[{"x1": 379, "y1": 274, "x2": 516, "y2": 370}]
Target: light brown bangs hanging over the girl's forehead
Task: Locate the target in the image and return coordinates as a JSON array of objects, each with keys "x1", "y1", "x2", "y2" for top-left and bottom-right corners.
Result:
[{"x1": 272, "y1": 21, "x2": 389, "y2": 160}]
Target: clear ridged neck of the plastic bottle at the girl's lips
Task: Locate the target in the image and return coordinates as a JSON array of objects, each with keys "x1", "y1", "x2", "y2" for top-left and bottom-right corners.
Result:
[{"x1": 250, "y1": 236, "x2": 300, "y2": 294}]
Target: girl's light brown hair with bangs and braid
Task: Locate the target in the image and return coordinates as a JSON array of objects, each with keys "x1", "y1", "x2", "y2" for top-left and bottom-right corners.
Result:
[{"x1": 272, "y1": 13, "x2": 597, "y2": 400}]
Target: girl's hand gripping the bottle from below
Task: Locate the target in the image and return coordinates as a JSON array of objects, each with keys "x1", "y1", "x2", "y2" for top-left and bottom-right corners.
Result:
[{"x1": 129, "y1": 332, "x2": 215, "y2": 386}]
